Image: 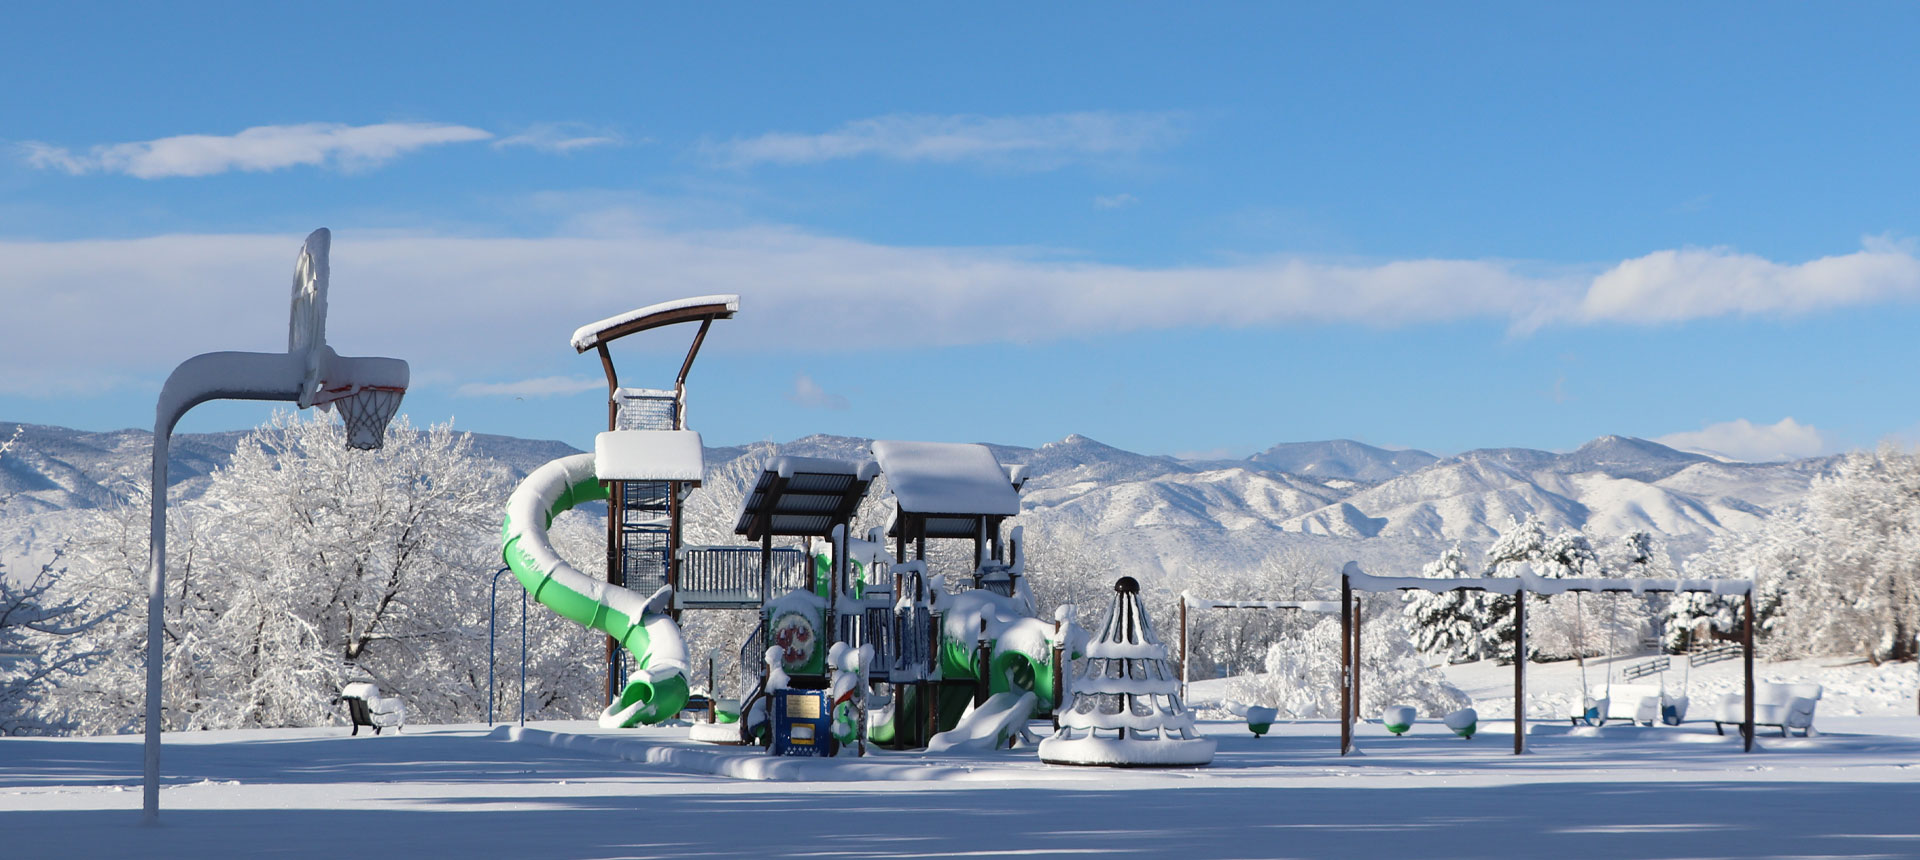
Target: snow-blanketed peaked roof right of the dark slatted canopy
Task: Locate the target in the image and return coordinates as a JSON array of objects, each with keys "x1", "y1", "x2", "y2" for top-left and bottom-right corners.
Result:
[{"x1": 872, "y1": 440, "x2": 1020, "y2": 516}]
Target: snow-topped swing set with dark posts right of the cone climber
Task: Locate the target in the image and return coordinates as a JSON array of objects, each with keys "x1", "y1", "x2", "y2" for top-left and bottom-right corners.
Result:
[{"x1": 1340, "y1": 562, "x2": 1758, "y2": 754}]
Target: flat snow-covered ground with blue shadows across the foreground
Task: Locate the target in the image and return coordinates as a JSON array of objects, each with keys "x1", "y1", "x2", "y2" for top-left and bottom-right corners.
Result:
[{"x1": 0, "y1": 679, "x2": 1920, "y2": 858}]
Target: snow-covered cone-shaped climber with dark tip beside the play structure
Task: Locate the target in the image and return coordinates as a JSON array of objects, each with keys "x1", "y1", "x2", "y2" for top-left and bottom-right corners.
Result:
[{"x1": 1041, "y1": 576, "x2": 1213, "y2": 766}]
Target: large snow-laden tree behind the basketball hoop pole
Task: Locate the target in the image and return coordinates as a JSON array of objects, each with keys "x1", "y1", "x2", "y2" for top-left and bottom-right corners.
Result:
[{"x1": 48, "y1": 413, "x2": 507, "y2": 731}]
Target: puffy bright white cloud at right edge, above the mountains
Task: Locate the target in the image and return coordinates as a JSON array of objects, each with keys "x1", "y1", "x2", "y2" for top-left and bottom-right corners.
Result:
[{"x1": 1572, "y1": 238, "x2": 1920, "y2": 323}]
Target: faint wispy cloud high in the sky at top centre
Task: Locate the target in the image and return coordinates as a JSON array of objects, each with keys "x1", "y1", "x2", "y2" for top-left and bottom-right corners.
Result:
[{"x1": 708, "y1": 111, "x2": 1183, "y2": 169}]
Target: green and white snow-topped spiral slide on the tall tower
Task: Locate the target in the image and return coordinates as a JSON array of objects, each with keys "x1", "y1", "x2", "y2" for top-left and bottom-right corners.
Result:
[{"x1": 501, "y1": 453, "x2": 687, "y2": 728}]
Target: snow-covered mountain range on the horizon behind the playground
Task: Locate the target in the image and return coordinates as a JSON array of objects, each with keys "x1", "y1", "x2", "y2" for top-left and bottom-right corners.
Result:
[{"x1": 0, "y1": 422, "x2": 1832, "y2": 574}]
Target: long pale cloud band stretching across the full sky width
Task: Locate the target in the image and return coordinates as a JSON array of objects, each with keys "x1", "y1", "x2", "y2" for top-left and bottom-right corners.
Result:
[{"x1": 11, "y1": 217, "x2": 1920, "y2": 395}]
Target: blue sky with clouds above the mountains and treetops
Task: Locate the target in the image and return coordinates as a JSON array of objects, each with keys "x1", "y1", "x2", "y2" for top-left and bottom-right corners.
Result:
[{"x1": 0, "y1": 4, "x2": 1920, "y2": 459}]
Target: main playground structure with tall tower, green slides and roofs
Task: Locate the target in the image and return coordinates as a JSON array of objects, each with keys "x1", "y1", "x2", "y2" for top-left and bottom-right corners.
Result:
[{"x1": 503, "y1": 296, "x2": 1090, "y2": 754}]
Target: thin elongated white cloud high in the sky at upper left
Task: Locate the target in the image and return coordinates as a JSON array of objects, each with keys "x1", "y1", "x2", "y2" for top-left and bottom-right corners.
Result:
[{"x1": 21, "y1": 123, "x2": 493, "y2": 179}]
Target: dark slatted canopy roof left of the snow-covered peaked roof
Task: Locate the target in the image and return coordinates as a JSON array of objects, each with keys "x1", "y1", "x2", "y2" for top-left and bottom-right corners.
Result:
[{"x1": 733, "y1": 457, "x2": 879, "y2": 539}]
